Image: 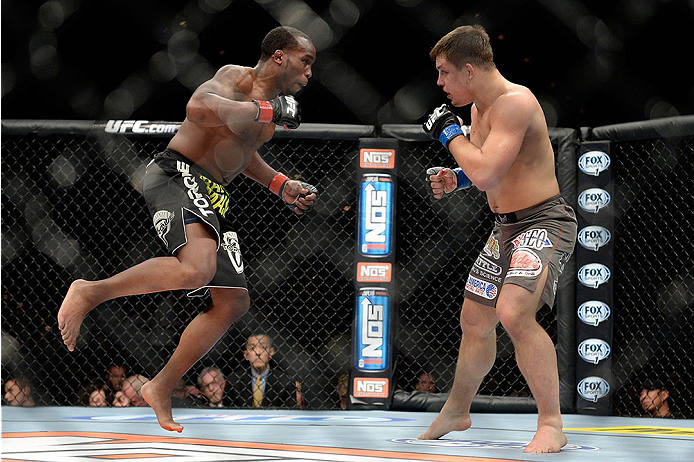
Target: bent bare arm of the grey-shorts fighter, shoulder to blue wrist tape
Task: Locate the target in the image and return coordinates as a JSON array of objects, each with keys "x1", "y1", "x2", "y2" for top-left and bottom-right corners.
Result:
[{"x1": 448, "y1": 92, "x2": 533, "y2": 191}]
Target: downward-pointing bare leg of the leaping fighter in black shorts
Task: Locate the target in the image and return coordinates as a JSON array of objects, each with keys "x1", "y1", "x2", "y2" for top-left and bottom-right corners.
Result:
[{"x1": 142, "y1": 288, "x2": 250, "y2": 432}]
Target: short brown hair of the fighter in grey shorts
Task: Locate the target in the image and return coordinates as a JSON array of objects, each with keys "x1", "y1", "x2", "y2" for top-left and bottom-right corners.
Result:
[{"x1": 429, "y1": 25, "x2": 496, "y2": 69}]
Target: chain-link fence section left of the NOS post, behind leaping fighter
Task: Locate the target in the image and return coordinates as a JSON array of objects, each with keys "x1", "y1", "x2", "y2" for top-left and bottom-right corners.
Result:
[{"x1": 2, "y1": 129, "x2": 364, "y2": 408}]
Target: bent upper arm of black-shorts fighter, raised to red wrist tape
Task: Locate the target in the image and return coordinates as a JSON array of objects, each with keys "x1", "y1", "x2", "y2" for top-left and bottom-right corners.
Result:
[{"x1": 186, "y1": 66, "x2": 258, "y2": 127}]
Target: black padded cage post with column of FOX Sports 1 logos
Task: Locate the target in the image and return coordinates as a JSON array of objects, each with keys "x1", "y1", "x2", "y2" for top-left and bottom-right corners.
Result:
[{"x1": 575, "y1": 141, "x2": 616, "y2": 415}]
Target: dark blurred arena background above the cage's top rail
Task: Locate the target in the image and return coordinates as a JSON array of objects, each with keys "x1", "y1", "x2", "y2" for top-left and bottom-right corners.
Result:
[{"x1": 1, "y1": 0, "x2": 694, "y2": 128}]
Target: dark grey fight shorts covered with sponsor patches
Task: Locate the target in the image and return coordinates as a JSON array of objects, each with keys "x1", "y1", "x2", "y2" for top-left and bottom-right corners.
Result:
[{"x1": 465, "y1": 195, "x2": 578, "y2": 308}]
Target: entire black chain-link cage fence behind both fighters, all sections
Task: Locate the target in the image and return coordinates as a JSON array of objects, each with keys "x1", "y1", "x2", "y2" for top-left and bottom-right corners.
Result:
[{"x1": 1, "y1": 120, "x2": 694, "y2": 418}]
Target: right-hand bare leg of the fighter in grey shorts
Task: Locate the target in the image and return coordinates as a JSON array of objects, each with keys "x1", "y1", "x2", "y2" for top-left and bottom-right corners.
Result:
[{"x1": 496, "y1": 268, "x2": 567, "y2": 453}]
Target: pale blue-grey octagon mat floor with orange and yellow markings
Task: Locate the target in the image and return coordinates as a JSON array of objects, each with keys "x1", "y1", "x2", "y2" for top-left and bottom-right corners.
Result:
[{"x1": 1, "y1": 406, "x2": 694, "y2": 462}]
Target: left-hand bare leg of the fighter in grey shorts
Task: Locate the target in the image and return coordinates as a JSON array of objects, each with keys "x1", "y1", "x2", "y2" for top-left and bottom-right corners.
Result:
[{"x1": 419, "y1": 298, "x2": 499, "y2": 440}]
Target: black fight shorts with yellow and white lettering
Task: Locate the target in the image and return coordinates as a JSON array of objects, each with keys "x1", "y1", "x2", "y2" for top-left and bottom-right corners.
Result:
[{"x1": 143, "y1": 149, "x2": 247, "y2": 297}]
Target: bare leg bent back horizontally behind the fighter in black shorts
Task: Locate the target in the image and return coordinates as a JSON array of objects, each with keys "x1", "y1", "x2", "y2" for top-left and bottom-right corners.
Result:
[{"x1": 58, "y1": 223, "x2": 217, "y2": 351}]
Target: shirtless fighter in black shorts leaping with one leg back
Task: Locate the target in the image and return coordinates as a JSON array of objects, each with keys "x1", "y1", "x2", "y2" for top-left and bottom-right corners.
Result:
[{"x1": 58, "y1": 27, "x2": 317, "y2": 432}]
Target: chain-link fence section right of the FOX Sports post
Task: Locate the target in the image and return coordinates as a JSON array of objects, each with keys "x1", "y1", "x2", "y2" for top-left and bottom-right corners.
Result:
[{"x1": 612, "y1": 136, "x2": 694, "y2": 418}]
